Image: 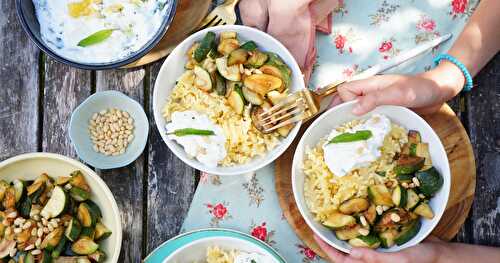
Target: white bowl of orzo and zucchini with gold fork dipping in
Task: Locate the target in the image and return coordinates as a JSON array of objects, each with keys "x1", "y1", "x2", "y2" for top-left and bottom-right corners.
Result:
[{"x1": 153, "y1": 26, "x2": 304, "y2": 175}]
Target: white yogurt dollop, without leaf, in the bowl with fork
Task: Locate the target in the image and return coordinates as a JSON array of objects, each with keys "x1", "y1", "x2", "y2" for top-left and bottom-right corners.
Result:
[{"x1": 166, "y1": 111, "x2": 227, "y2": 167}]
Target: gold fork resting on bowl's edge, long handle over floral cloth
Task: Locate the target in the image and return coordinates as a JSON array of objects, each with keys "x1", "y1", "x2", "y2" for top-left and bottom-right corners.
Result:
[{"x1": 255, "y1": 34, "x2": 452, "y2": 133}]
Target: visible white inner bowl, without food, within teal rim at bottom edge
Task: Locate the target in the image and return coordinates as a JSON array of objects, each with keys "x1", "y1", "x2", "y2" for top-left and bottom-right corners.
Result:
[{"x1": 164, "y1": 237, "x2": 279, "y2": 263}]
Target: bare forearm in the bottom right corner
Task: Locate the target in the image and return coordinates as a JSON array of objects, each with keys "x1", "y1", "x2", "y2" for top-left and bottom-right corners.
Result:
[{"x1": 436, "y1": 243, "x2": 500, "y2": 263}]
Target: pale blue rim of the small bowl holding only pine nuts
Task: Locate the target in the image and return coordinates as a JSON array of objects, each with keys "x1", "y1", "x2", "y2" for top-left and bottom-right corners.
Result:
[{"x1": 68, "y1": 90, "x2": 149, "y2": 169}]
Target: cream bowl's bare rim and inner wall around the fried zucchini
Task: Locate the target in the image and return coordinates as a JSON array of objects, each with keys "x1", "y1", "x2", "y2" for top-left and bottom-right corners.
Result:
[{"x1": 0, "y1": 153, "x2": 122, "y2": 263}]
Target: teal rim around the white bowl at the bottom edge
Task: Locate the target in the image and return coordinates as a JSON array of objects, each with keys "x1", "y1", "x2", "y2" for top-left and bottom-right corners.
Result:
[{"x1": 142, "y1": 228, "x2": 286, "y2": 263}]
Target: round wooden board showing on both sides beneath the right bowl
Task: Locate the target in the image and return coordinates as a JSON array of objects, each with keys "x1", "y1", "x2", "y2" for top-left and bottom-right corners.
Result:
[{"x1": 275, "y1": 105, "x2": 476, "y2": 257}]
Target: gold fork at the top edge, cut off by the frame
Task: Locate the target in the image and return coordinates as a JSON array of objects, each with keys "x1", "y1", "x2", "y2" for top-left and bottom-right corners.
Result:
[{"x1": 198, "y1": 0, "x2": 239, "y2": 30}]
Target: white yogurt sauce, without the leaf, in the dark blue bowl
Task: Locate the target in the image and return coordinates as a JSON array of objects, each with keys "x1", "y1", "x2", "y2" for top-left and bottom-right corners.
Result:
[{"x1": 33, "y1": 0, "x2": 170, "y2": 63}]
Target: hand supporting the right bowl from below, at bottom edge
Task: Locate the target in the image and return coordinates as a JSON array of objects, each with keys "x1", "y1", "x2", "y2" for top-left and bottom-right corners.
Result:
[{"x1": 314, "y1": 236, "x2": 446, "y2": 263}]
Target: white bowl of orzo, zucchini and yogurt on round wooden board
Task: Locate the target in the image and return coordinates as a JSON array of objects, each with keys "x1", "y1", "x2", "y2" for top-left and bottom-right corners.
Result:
[{"x1": 292, "y1": 102, "x2": 450, "y2": 252}]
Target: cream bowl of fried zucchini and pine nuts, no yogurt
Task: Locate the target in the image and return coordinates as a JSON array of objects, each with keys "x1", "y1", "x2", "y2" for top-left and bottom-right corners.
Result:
[{"x1": 0, "y1": 153, "x2": 122, "y2": 263}]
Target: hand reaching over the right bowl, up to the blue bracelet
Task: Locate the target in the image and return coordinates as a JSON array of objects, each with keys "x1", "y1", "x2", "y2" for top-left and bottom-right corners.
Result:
[{"x1": 339, "y1": 61, "x2": 465, "y2": 115}]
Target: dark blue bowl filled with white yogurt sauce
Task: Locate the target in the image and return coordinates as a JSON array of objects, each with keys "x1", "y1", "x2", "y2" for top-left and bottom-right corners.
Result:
[{"x1": 16, "y1": 0, "x2": 177, "y2": 70}]
